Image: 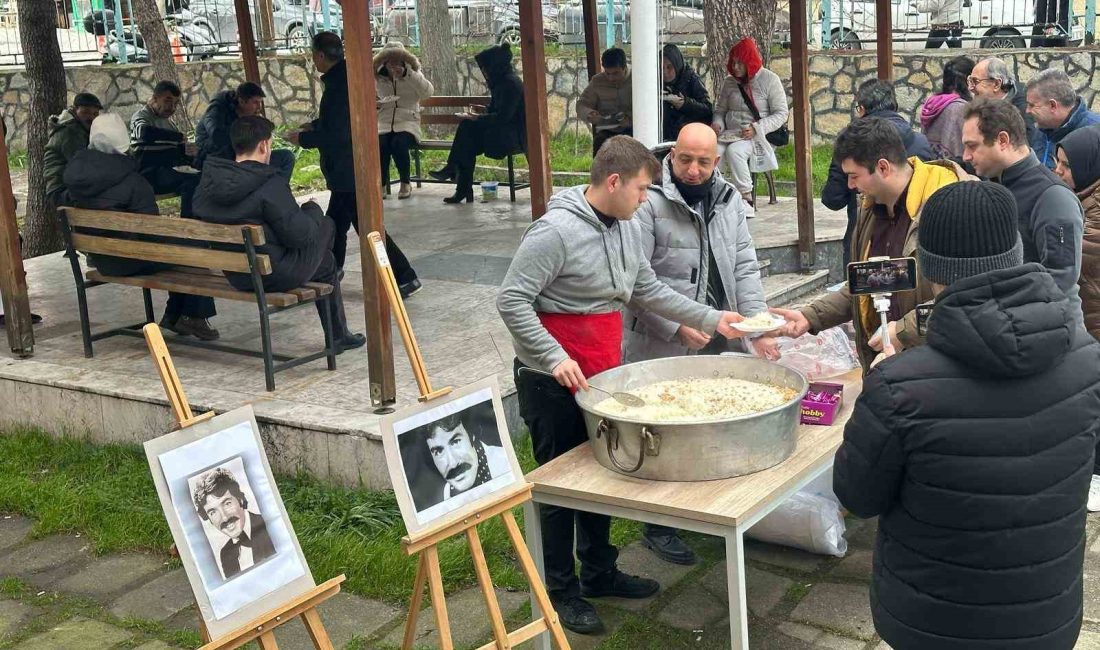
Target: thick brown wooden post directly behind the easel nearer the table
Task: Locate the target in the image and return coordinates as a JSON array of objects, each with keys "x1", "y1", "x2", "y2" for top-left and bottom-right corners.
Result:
[{"x1": 341, "y1": 0, "x2": 398, "y2": 406}]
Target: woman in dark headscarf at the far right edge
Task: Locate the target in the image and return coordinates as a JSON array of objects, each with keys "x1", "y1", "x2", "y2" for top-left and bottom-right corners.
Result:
[{"x1": 1054, "y1": 126, "x2": 1100, "y2": 340}]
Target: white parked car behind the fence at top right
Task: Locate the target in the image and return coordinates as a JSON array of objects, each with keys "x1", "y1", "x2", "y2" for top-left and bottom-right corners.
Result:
[{"x1": 810, "y1": 0, "x2": 1085, "y2": 49}]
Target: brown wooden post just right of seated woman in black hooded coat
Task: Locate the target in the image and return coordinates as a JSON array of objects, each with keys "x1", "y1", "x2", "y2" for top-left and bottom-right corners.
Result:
[{"x1": 514, "y1": 1, "x2": 553, "y2": 221}]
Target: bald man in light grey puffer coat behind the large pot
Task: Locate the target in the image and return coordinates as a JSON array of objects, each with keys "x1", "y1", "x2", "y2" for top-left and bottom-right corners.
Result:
[{"x1": 623, "y1": 123, "x2": 779, "y2": 564}]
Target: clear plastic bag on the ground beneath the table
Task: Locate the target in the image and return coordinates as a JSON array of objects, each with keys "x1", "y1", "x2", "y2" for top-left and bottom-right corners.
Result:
[{"x1": 746, "y1": 470, "x2": 848, "y2": 558}]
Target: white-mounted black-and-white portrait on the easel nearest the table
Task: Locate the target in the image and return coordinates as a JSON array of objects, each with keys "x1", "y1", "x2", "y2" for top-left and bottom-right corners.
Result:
[{"x1": 382, "y1": 377, "x2": 524, "y2": 533}]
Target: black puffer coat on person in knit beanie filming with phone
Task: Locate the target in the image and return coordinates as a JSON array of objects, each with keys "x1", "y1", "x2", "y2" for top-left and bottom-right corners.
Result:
[{"x1": 833, "y1": 264, "x2": 1100, "y2": 650}]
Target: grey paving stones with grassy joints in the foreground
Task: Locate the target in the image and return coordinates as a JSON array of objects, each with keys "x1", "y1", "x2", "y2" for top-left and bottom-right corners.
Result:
[{"x1": 0, "y1": 514, "x2": 1100, "y2": 650}]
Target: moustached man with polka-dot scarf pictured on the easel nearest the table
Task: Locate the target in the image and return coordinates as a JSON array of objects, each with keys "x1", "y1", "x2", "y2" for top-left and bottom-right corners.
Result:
[{"x1": 416, "y1": 414, "x2": 509, "y2": 509}]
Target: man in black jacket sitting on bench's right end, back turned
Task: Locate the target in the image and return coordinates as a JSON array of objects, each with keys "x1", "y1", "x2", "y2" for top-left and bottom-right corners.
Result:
[{"x1": 195, "y1": 115, "x2": 366, "y2": 351}]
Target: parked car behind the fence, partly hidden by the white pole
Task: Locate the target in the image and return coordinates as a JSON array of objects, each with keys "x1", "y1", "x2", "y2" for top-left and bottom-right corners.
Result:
[{"x1": 558, "y1": 0, "x2": 705, "y2": 44}]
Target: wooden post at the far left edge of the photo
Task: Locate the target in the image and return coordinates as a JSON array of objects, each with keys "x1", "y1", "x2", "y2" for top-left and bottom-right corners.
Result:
[{"x1": 0, "y1": 123, "x2": 34, "y2": 356}]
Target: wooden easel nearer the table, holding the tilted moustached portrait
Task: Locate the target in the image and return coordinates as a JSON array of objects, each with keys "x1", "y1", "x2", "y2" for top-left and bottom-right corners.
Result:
[{"x1": 367, "y1": 232, "x2": 569, "y2": 650}]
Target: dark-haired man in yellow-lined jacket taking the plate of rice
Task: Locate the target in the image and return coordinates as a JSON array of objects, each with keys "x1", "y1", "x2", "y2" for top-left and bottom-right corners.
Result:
[{"x1": 772, "y1": 118, "x2": 959, "y2": 372}]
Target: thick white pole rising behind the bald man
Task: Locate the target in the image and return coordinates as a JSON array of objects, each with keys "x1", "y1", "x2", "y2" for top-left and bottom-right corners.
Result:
[{"x1": 630, "y1": 2, "x2": 661, "y2": 147}]
